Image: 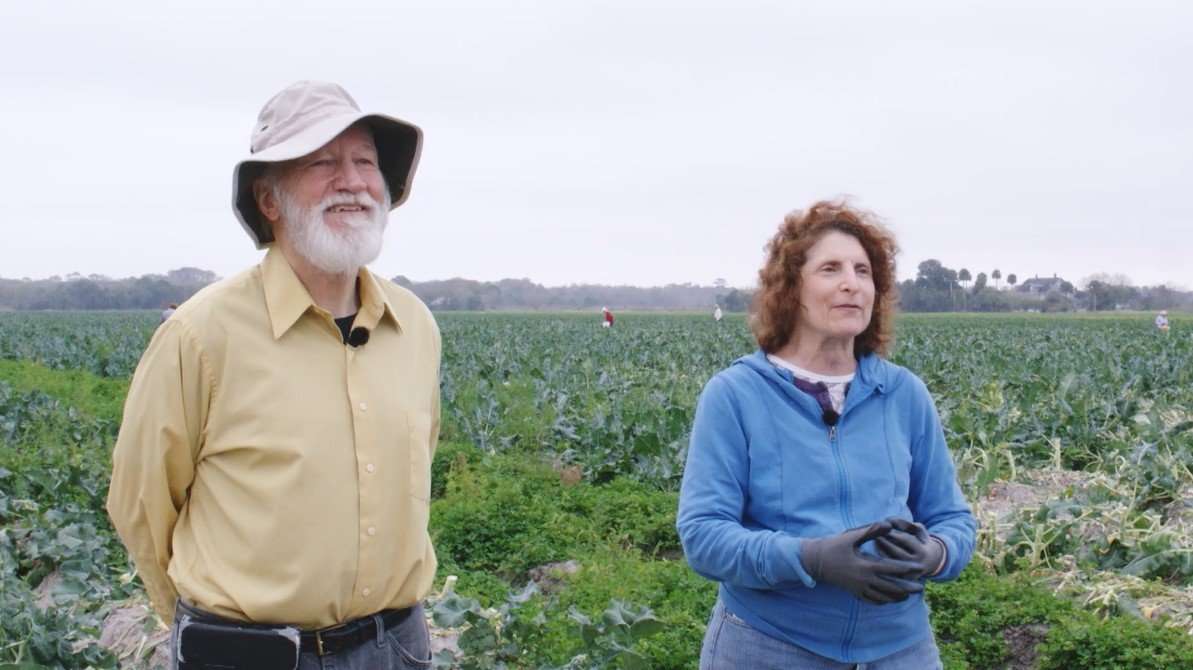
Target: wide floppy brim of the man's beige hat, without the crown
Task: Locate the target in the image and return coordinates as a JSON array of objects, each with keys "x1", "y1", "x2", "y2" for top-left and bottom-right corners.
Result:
[{"x1": 231, "y1": 113, "x2": 422, "y2": 249}]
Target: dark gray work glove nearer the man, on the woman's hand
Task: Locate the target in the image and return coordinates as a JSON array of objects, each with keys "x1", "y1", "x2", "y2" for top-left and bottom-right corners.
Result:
[{"x1": 801, "y1": 521, "x2": 923, "y2": 604}]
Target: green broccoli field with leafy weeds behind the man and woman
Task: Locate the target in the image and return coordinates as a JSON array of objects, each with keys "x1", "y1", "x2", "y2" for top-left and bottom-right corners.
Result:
[{"x1": 0, "y1": 312, "x2": 1193, "y2": 669}]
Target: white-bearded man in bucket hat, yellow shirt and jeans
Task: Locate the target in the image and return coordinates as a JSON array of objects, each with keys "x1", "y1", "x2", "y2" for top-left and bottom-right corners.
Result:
[{"x1": 107, "y1": 81, "x2": 440, "y2": 670}]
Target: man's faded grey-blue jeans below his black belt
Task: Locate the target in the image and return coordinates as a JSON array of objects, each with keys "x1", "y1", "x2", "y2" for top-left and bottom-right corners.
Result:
[{"x1": 169, "y1": 604, "x2": 431, "y2": 670}]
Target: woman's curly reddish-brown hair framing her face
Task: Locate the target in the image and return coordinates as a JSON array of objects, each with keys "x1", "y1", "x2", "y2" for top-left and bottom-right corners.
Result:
[{"x1": 750, "y1": 200, "x2": 898, "y2": 356}]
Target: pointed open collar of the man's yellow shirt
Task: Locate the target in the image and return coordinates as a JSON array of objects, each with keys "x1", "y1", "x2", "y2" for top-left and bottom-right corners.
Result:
[{"x1": 261, "y1": 246, "x2": 402, "y2": 340}]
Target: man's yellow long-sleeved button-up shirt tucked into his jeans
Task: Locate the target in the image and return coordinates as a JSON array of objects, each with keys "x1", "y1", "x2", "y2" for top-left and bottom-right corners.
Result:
[{"x1": 107, "y1": 249, "x2": 440, "y2": 628}]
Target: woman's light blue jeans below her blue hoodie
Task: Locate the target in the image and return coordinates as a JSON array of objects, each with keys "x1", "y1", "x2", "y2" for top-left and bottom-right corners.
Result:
[{"x1": 700, "y1": 600, "x2": 944, "y2": 670}]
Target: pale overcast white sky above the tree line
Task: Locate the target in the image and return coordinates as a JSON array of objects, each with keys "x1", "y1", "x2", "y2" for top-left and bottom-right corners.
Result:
[{"x1": 0, "y1": 0, "x2": 1193, "y2": 287}]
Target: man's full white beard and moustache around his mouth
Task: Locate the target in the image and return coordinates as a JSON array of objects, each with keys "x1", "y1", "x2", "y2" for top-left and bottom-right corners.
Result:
[{"x1": 274, "y1": 188, "x2": 390, "y2": 274}]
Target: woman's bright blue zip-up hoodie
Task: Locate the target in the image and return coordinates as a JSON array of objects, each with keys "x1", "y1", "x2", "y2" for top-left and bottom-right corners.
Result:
[{"x1": 676, "y1": 350, "x2": 977, "y2": 663}]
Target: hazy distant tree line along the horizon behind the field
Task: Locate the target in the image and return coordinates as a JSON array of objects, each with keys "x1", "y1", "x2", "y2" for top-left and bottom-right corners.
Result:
[{"x1": 0, "y1": 259, "x2": 1193, "y2": 312}]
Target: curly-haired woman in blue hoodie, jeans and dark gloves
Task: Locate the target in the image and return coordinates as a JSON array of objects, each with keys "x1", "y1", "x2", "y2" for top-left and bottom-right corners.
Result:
[{"x1": 676, "y1": 201, "x2": 976, "y2": 670}]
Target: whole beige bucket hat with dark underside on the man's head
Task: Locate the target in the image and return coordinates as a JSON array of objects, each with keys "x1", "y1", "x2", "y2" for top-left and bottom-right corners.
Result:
[{"x1": 231, "y1": 81, "x2": 422, "y2": 249}]
